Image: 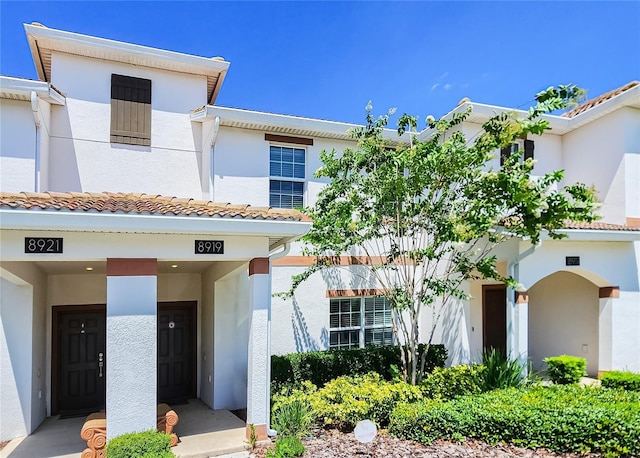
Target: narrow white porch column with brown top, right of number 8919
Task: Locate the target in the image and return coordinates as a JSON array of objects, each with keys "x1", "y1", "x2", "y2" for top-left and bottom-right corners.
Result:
[{"x1": 247, "y1": 258, "x2": 271, "y2": 440}]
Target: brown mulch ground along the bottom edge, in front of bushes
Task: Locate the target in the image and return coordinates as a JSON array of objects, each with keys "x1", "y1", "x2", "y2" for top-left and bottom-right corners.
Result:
[{"x1": 251, "y1": 429, "x2": 600, "y2": 458}]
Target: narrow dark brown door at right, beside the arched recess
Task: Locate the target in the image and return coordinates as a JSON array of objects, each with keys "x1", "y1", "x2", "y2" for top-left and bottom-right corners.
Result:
[{"x1": 482, "y1": 285, "x2": 507, "y2": 355}]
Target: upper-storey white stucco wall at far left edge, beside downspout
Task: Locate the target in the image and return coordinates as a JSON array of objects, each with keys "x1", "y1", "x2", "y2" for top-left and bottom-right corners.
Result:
[{"x1": 0, "y1": 99, "x2": 36, "y2": 192}]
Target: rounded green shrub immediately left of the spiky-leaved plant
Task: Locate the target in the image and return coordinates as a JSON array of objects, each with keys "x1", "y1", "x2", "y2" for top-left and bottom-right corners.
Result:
[{"x1": 421, "y1": 364, "x2": 485, "y2": 400}]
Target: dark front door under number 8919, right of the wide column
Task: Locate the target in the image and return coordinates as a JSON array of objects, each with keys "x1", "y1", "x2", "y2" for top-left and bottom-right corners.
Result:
[{"x1": 158, "y1": 302, "x2": 196, "y2": 403}]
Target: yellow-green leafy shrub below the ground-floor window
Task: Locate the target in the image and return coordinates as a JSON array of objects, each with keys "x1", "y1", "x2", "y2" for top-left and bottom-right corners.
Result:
[{"x1": 310, "y1": 373, "x2": 422, "y2": 430}]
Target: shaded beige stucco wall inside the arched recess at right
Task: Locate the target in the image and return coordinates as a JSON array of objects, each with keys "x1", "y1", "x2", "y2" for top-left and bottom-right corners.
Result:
[{"x1": 529, "y1": 272, "x2": 599, "y2": 376}]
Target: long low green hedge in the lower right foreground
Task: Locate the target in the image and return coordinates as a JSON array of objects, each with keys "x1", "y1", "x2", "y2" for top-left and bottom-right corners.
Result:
[{"x1": 389, "y1": 385, "x2": 640, "y2": 457}]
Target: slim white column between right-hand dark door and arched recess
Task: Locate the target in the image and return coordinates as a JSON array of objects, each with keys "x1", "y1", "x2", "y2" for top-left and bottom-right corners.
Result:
[{"x1": 507, "y1": 288, "x2": 529, "y2": 363}]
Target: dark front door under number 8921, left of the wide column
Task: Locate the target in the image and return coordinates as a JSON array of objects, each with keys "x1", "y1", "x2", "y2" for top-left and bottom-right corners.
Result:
[{"x1": 53, "y1": 306, "x2": 106, "y2": 415}]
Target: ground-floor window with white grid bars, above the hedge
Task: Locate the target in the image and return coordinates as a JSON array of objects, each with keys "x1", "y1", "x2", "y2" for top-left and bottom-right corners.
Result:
[{"x1": 329, "y1": 296, "x2": 394, "y2": 348}]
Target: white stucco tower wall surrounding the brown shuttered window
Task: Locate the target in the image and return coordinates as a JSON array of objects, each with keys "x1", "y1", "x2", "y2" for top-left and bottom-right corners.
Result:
[{"x1": 49, "y1": 52, "x2": 206, "y2": 198}]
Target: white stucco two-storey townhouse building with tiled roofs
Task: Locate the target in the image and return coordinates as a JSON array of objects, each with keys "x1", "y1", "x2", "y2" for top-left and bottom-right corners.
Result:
[{"x1": 0, "y1": 24, "x2": 640, "y2": 441}]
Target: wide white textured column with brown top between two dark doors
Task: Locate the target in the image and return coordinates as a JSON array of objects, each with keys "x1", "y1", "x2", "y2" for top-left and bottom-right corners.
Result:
[{"x1": 105, "y1": 259, "x2": 158, "y2": 440}]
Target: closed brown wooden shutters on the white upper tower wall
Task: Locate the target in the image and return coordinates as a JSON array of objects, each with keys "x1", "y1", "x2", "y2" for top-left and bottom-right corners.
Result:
[{"x1": 111, "y1": 74, "x2": 151, "y2": 146}]
